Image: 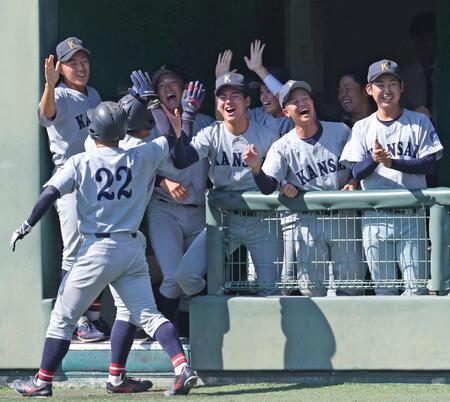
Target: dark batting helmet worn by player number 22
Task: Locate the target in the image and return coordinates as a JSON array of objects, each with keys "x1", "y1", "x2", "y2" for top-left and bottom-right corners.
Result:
[{"x1": 87, "y1": 102, "x2": 127, "y2": 142}]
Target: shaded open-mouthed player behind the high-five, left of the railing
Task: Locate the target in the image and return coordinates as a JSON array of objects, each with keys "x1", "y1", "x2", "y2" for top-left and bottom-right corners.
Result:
[{"x1": 147, "y1": 65, "x2": 214, "y2": 328}]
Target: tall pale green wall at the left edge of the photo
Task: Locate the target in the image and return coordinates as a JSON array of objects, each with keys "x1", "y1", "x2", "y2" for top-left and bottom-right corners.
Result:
[{"x1": 0, "y1": 0, "x2": 46, "y2": 368}]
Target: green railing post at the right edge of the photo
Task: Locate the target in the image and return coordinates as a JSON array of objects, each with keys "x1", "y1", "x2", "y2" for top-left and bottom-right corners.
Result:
[{"x1": 429, "y1": 204, "x2": 450, "y2": 292}]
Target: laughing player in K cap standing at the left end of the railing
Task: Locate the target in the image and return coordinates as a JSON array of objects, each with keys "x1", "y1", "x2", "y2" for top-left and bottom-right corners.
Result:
[{"x1": 174, "y1": 73, "x2": 283, "y2": 295}]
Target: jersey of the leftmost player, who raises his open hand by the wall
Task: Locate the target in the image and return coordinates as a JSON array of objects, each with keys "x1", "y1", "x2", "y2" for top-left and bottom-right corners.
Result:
[{"x1": 38, "y1": 83, "x2": 101, "y2": 167}]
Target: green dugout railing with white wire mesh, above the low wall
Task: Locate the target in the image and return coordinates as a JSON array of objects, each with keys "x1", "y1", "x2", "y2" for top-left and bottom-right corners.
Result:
[{"x1": 206, "y1": 188, "x2": 450, "y2": 296}]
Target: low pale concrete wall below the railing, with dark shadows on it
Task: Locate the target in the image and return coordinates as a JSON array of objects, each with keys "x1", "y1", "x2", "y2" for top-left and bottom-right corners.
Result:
[{"x1": 190, "y1": 296, "x2": 450, "y2": 372}]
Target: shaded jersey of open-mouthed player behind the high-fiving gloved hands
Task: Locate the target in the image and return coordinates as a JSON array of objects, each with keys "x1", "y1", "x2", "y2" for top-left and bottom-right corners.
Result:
[{"x1": 152, "y1": 113, "x2": 214, "y2": 205}]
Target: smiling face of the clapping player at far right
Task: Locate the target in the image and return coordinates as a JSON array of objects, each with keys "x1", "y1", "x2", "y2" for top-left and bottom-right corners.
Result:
[{"x1": 366, "y1": 74, "x2": 403, "y2": 113}]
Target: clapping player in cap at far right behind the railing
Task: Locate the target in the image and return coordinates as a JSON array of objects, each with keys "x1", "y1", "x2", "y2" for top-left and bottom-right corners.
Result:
[{"x1": 341, "y1": 60, "x2": 443, "y2": 295}]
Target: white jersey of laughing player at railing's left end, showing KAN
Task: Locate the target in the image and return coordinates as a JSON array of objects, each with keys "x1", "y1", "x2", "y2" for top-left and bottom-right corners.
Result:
[{"x1": 191, "y1": 120, "x2": 279, "y2": 191}]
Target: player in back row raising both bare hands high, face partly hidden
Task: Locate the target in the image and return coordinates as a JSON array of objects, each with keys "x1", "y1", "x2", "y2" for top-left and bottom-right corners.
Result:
[{"x1": 215, "y1": 40, "x2": 294, "y2": 135}]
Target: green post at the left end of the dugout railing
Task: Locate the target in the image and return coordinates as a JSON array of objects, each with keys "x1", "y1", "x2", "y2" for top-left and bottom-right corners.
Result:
[{"x1": 206, "y1": 191, "x2": 225, "y2": 295}]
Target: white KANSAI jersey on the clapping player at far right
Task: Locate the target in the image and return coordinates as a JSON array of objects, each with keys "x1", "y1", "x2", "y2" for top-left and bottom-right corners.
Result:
[{"x1": 341, "y1": 109, "x2": 443, "y2": 190}]
